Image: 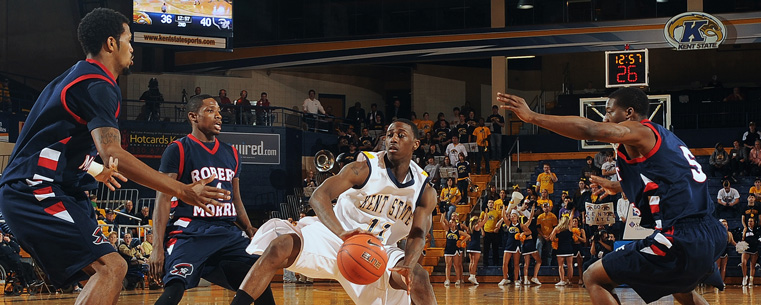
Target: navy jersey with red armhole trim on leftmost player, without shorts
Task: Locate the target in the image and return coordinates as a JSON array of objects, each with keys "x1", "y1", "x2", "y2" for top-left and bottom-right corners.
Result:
[{"x1": 0, "y1": 59, "x2": 122, "y2": 192}]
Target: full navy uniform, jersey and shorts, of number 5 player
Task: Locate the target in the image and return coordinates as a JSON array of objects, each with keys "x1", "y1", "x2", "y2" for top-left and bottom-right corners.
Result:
[{"x1": 602, "y1": 120, "x2": 727, "y2": 303}]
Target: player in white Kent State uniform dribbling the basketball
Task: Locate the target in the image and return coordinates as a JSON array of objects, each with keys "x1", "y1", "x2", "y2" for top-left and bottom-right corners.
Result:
[{"x1": 231, "y1": 119, "x2": 436, "y2": 305}]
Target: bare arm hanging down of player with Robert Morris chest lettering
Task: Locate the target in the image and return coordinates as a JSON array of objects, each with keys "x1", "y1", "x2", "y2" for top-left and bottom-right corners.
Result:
[{"x1": 148, "y1": 173, "x2": 177, "y2": 280}]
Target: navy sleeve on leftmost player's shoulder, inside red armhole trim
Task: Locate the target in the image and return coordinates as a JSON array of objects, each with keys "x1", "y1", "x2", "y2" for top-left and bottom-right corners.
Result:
[{"x1": 66, "y1": 79, "x2": 120, "y2": 131}]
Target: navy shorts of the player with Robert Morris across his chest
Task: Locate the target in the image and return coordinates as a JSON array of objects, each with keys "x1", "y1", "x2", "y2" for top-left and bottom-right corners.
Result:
[{"x1": 163, "y1": 218, "x2": 259, "y2": 290}]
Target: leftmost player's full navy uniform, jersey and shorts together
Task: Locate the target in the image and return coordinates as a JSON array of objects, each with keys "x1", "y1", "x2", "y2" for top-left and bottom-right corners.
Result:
[{"x1": 0, "y1": 59, "x2": 121, "y2": 287}]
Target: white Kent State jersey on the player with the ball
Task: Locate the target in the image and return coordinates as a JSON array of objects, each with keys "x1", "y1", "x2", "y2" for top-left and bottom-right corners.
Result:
[{"x1": 333, "y1": 152, "x2": 428, "y2": 245}]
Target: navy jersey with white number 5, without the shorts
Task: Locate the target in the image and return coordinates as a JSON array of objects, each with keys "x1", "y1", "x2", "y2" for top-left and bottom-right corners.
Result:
[{"x1": 616, "y1": 120, "x2": 713, "y2": 229}]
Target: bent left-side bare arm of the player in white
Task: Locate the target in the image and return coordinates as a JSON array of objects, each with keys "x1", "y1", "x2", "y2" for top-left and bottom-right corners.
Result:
[{"x1": 309, "y1": 161, "x2": 370, "y2": 240}]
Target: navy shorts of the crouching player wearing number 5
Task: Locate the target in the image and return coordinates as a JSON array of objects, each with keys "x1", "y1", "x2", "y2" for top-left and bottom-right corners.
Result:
[{"x1": 602, "y1": 216, "x2": 727, "y2": 303}]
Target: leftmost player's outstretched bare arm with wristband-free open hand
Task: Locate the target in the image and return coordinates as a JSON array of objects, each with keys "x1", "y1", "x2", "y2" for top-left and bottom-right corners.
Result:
[{"x1": 90, "y1": 127, "x2": 230, "y2": 214}]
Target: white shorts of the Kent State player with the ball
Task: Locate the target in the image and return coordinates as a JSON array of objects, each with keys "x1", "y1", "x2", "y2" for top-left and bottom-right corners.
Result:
[{"x1": 246, "y1": 217, "x2": 411, "y2": 305}]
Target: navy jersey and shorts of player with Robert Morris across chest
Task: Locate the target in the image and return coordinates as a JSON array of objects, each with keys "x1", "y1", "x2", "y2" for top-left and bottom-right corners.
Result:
[{"x1": 159, "y1": 135, "x2": 255, "y2": 290}]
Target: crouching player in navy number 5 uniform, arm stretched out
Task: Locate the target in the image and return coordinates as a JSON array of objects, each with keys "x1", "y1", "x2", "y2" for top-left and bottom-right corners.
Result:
[{"x1": 497, "y1": 88, "x2": 727, "y2": 304}]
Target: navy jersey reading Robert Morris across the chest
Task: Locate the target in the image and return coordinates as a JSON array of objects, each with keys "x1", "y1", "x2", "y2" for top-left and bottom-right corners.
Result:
[{"x1": 159, "y1": 134, "x2": 240, "y2": 221}]
